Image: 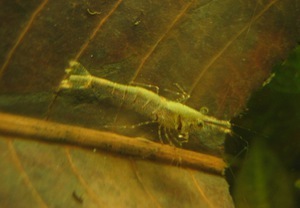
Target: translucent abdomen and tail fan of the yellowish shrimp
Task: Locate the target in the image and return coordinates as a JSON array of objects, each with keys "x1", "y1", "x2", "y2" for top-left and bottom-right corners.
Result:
[{"x1": 60, "y1": 61, "x2": 166, "y2": 120}]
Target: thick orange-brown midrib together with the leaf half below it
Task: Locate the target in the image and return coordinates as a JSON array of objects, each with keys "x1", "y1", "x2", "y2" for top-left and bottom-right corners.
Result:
[{"x1": 0, "y1": 114, "x2": 233, "y2": 207}]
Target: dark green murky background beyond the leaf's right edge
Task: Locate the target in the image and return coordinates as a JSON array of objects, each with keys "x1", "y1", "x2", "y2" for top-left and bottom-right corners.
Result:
[{"x1": 227, "y1": 46, "x2": 300, "y2": 207}]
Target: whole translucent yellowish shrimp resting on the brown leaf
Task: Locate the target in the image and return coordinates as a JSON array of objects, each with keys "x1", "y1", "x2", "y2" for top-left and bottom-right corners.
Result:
[{"x1": 60, "y1": 61, "x2": 231, "y2": 147}]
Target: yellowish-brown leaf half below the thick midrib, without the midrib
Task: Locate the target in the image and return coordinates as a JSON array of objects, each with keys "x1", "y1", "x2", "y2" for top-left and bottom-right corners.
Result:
[{"x1": 0, "y1": 137, "x2": 232, "y2": 207}]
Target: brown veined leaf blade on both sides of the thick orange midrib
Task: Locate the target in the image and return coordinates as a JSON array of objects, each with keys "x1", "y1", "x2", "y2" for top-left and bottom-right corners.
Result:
[{"x1": 0, "y1": 0, "x2": 299, "y2": 207}]
